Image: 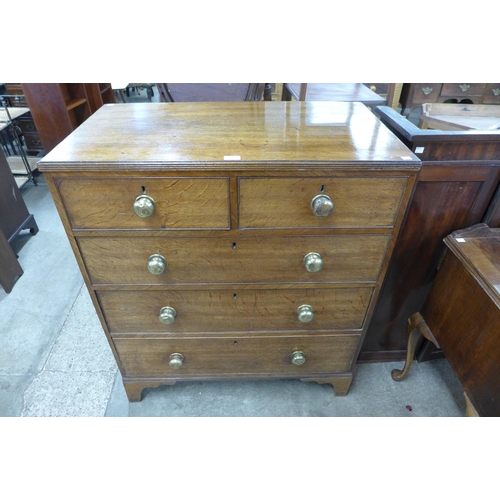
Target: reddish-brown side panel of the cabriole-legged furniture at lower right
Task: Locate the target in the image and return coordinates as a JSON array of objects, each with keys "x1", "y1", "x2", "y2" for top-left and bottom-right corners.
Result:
[{"x1": 422, "y1": 246, "x2": 500, "y2": 417}]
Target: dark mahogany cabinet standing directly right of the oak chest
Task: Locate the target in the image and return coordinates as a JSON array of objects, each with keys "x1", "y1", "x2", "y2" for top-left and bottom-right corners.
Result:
[{"x1": 359, "y1": 107, "x2": 500, "y2": 361}]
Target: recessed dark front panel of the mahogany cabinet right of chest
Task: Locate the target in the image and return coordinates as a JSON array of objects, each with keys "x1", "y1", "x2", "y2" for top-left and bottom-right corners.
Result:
[{"x1": 360, "y1": 180, "x2": 482, "y2": 359}]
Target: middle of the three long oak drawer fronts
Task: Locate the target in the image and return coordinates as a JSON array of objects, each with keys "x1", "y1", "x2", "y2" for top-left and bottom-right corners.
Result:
[{"x1": 98, "y1": 287, "x2": 373, "y2": 334}]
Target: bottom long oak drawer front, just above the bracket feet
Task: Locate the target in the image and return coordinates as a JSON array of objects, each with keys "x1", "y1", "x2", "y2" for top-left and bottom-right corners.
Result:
[{"x1": 114, "y1": 334, "x2": 360, "y2": 378}]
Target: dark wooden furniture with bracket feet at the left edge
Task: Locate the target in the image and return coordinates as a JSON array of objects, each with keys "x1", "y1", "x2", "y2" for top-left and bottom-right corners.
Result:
[{"x1": 0, "y1": 149, "x2": 38, "y2": 293}]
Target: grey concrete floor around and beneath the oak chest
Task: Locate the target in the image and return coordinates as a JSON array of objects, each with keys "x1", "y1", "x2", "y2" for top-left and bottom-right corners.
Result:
[{"x1": 0, "y1": 91, "x2": 465, "y2": 417}]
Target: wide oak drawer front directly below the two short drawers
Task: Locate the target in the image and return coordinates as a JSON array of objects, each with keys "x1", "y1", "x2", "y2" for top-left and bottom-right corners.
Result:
[{"x1": 77, "y1": 234, "x2": 390, "y2": 285}]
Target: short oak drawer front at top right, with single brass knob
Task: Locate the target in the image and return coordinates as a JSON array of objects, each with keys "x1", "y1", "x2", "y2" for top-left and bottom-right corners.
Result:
[{"x1": 239, "y1": 177, "x2": 408, "y2": 229}]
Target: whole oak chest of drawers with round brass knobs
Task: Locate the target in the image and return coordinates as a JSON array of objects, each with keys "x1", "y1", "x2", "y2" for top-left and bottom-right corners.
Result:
[{"x1": 39, "y1": 102, "x2": 420, "y2": 401}]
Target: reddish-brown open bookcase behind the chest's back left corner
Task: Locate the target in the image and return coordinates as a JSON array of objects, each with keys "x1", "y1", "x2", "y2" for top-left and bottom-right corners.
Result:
[{"x1": 21, "y1": 83, "x2": 115, "y2": 153}]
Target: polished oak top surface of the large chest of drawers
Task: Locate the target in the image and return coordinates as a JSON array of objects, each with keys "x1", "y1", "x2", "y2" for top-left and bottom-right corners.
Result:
[{"x1": 39, "y1": 102, "x2": 419, "y2": 171}]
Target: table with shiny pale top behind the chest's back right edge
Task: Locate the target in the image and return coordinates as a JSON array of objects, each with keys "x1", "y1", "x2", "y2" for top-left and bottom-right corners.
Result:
[{"x1": 281, "y1": 83, "x2": 401, "y2": 109}]
